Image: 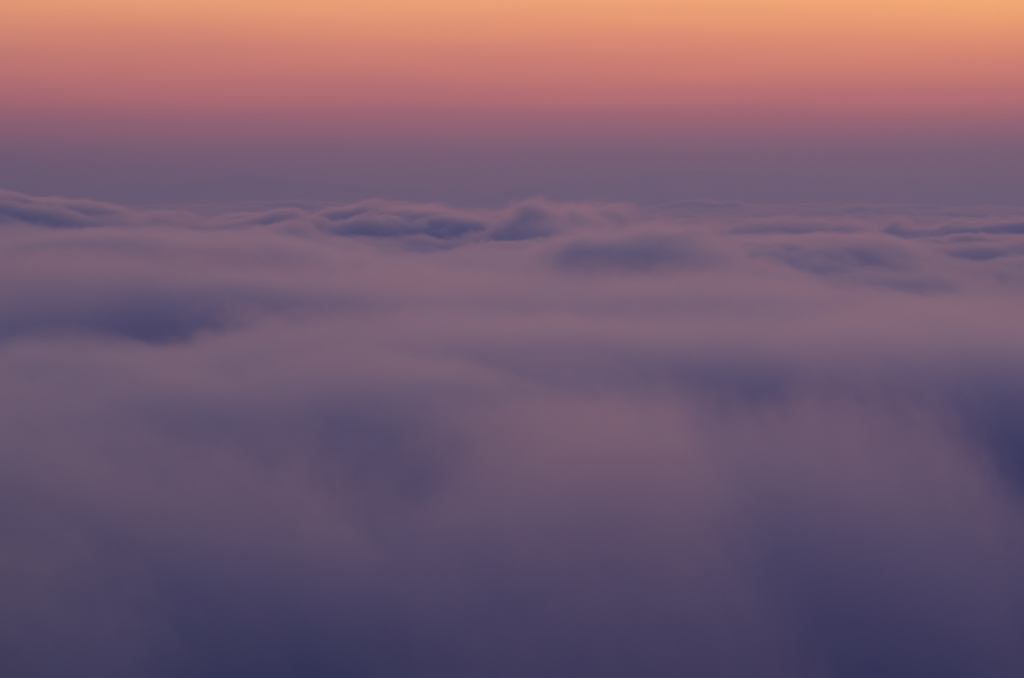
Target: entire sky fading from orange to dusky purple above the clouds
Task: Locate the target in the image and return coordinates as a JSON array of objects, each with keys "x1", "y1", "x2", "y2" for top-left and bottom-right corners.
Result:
[{"x1": 0, "y1": 0, "x2": 1024, "y2": 202}]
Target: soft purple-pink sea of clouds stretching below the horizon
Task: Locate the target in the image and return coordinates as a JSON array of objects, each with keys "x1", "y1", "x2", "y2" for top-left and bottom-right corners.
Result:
[{"x1": 0, "y1": 193, "x2": 1024, "y2": 678}]
